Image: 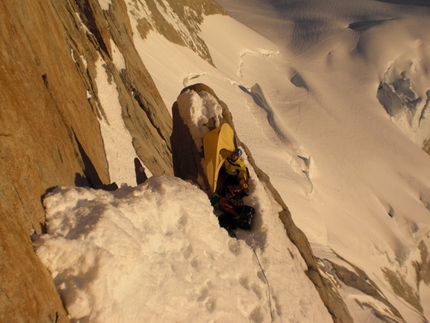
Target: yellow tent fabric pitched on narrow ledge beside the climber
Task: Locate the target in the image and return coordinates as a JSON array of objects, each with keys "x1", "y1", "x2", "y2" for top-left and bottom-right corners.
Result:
[{"x1": 203, "y1": 123, "x2": 235, "y2": 193}]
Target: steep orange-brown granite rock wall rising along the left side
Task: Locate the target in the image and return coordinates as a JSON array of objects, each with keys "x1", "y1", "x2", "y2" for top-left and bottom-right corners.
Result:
[{"x1": 0, "y1": 0, "x2": 173, "y2": 322}]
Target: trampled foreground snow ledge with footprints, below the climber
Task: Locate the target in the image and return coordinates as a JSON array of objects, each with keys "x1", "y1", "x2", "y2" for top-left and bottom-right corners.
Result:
[{"x1": 35, "y1": 176, "x2": 329, "y2": 322}]
